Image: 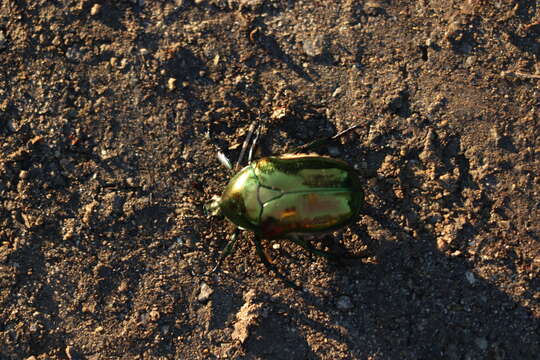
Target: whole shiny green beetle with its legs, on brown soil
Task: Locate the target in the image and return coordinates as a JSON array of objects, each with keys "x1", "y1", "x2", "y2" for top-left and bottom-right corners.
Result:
[{"x1": 206, "y1": 123, "x2": 364, "y2": 288}]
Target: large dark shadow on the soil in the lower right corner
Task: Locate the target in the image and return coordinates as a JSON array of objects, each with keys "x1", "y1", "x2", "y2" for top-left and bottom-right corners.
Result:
[{"x1": 255, "y1": 197, "x2": 540, "y2": 358}]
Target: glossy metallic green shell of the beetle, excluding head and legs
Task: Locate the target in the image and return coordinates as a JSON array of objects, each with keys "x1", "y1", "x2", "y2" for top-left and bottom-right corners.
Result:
[{"x1": 219, "y1": 154, "x2": 364, "y2": 238}]
